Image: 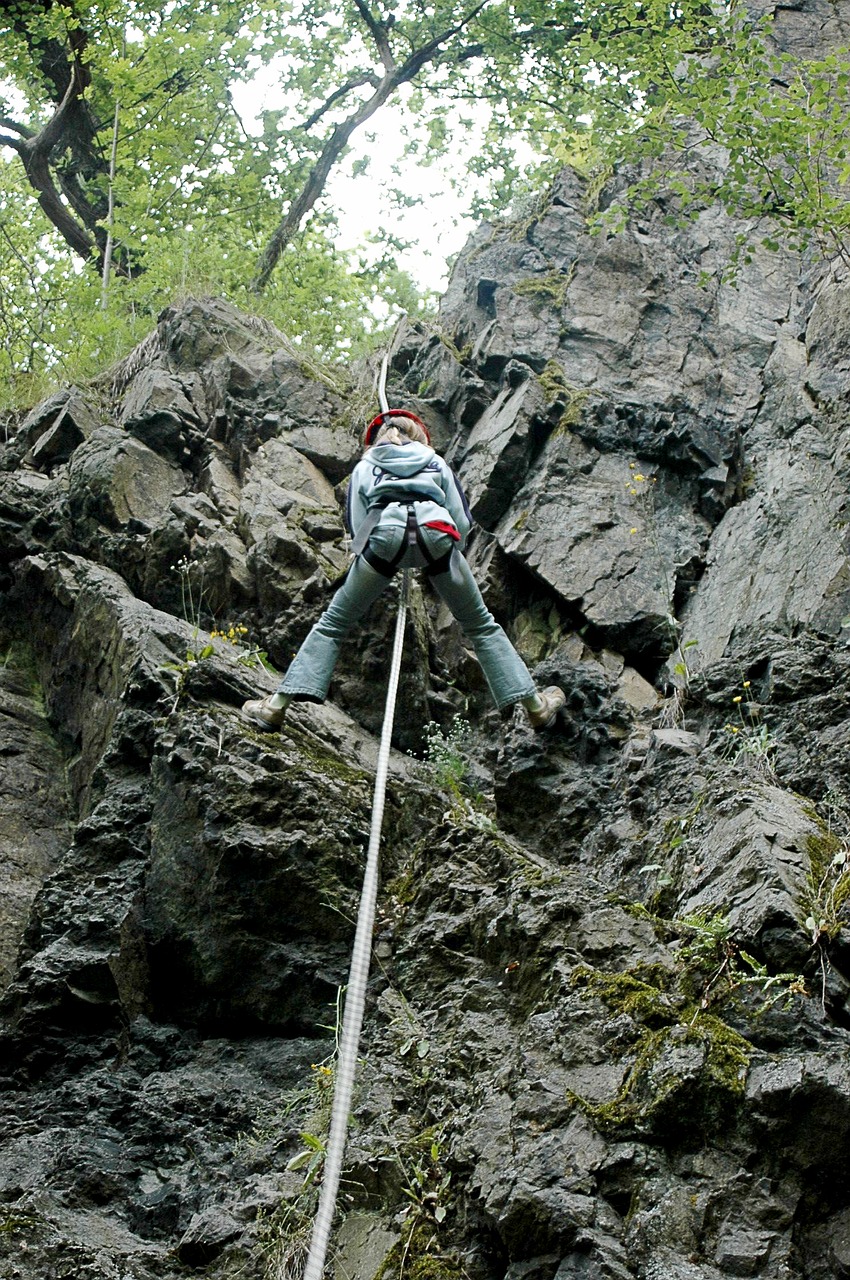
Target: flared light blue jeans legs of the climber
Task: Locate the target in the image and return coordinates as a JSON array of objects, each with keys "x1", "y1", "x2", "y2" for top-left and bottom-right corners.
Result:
[{"x1": 278, "y1": 543, "x2": 535, "y2": 709}]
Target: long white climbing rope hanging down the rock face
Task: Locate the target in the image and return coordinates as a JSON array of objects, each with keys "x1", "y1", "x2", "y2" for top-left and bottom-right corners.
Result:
[{"x1": 303, "y1": 356, "x2": 407, "y2": 1280}]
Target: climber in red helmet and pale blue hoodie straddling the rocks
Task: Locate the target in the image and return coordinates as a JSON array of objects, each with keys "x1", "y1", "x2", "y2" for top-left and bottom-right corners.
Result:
[{"x1": 242, "y1": 408, "x2": 566, "y2": 730}]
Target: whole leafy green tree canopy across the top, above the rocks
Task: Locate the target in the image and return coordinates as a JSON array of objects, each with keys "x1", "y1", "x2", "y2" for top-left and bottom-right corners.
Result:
[{"x1": 0, "y1": 0, "x2": 850, "y2": 399}]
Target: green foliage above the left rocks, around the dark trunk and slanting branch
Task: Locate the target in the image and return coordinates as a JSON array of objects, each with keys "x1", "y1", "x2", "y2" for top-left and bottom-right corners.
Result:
[{"x1": 0, "y1": 0, "x2": 445, "y2": 406}]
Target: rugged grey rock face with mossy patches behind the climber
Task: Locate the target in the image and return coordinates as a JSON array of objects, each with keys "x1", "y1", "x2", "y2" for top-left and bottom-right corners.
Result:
[{"x1": 0, "y1": 5, "x2": 850, "y2": 1280}]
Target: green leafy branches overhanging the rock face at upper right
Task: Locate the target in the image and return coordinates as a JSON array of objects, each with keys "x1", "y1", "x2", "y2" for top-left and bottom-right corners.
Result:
[{"x1": 583, "y1": 3, "x2": 850, "y2": 267}]
